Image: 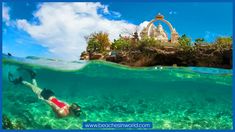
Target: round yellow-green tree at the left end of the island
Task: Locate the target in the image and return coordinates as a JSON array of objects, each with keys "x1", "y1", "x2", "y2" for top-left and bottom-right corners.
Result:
[{"x1": 86, "y1": 32, "x2": 111, "y2": 53}]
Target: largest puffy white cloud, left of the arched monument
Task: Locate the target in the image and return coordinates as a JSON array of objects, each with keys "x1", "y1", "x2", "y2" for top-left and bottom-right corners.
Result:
[{"x1": 16, "y1": 2, "x2": 136, "y2": 60}]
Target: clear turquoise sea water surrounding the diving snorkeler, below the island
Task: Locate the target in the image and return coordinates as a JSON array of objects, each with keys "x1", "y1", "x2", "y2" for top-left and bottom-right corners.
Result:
[{"x1": 2, "y1": 57, "x2": 233, "y2": 129}]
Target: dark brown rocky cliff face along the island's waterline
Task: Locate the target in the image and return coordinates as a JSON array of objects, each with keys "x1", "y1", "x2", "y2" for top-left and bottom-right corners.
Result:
[{"x1": 81, "y1": 45, "x2": 232, "y2": 69}]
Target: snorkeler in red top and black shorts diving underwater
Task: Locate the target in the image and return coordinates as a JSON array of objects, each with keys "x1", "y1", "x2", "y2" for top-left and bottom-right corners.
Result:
[{"x1": 8, "y1": 69, "x2": 81, "y2": 118}]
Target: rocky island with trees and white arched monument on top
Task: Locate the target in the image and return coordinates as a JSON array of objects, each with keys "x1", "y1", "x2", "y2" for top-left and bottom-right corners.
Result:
[{"x1": 80, "y1": 13, "x2": 232, "y2": 69}]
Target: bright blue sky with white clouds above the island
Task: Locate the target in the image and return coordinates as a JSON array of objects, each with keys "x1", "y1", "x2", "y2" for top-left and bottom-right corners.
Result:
[{"x1": 2, "y1": 2, "x2": 233, "y2": 60}]
